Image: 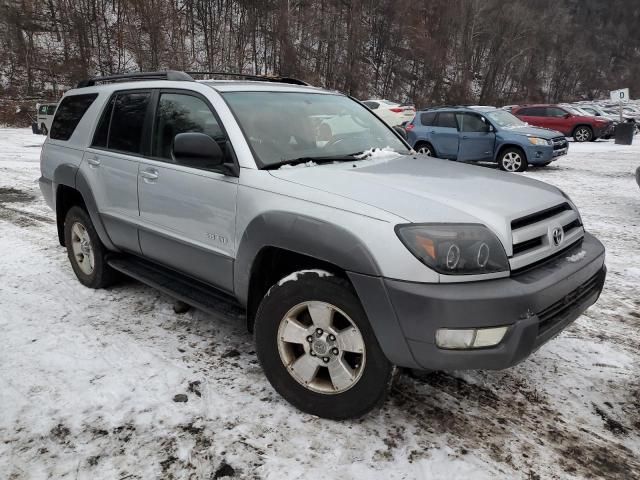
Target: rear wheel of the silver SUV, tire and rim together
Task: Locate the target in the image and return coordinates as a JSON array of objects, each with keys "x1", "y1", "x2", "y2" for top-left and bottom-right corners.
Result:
[{"x1": 64, "y1": 206, "x2": 116, "y2": 288}]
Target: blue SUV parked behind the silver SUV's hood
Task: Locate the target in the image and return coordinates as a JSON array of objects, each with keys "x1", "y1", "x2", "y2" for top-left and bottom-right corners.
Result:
[{"x1": 405, "y1": 107, "x2": 569, "y2": 172}]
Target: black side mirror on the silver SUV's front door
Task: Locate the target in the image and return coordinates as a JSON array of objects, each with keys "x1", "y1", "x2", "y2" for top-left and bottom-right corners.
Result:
[{"x1": 173, "y1": 132, "x2": 224, "y2": 170}]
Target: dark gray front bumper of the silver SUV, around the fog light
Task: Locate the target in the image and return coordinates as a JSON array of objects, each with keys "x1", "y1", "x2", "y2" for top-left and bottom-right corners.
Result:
[{"x1": 350, "y1": 233, "x2": 606, "y2": 370}]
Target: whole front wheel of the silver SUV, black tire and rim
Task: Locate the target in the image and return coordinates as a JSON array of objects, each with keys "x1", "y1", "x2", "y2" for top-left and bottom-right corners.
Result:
[{"x1": 254, "y1": 271, "x2": 395, "y2": 420}]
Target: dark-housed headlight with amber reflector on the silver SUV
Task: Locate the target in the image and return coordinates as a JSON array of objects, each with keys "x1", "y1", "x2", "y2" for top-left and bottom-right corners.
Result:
[{"x1": 396, "y1": 223, "x2": 509, "y2": 275}]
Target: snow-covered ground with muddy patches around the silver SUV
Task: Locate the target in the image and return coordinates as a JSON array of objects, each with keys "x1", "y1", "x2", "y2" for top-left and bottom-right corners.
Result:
[{"x1": 0, "y1": 129, "x2": 640, "y2": 480}]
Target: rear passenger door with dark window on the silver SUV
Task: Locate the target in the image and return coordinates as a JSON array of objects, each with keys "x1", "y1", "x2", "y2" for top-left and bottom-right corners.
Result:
[{"x1": 82, "y1": 90, "x2": 151, "y2": 253}]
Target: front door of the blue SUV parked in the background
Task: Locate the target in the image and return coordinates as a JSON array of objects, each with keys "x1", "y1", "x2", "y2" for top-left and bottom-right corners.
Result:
[{"x1": 456, "y1": 113, "x2": 496, "y2": 161}]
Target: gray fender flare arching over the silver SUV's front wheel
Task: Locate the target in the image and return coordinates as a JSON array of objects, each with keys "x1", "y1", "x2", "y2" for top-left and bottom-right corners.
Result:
[{"x1": 234, "y1": 211, "x2": 417, "y2": 366}]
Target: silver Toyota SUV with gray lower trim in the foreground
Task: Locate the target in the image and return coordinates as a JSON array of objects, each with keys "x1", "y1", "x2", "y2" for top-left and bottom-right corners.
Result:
[{"x1": 40, "y1": 72, "x2": 606, "y2": 419}]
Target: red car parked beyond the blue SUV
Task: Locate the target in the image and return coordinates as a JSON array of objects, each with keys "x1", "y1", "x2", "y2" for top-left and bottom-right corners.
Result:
[{"x1": 511, "y1": 104, "x2": 613, "y2": 142}]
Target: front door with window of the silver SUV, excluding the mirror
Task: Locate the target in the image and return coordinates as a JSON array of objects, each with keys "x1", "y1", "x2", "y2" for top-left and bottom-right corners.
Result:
[{"x1": 138, "y1": 90, "x2": 238, "y2": 292}]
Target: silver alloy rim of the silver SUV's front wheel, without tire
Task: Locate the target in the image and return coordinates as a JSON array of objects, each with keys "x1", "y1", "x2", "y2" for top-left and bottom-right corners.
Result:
[{"x1": 278, "y1": 301, "x2": 366, "y2": 394}]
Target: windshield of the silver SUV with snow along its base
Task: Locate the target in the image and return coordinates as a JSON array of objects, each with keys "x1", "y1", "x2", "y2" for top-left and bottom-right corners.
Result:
[{"x1": 222, "y1": 92, "x2": 409, "y2": 168}]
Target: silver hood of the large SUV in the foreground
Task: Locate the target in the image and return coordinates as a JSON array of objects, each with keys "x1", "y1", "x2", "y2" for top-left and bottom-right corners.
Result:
[{"x1": 270, "y1": 155, "x2": 566, "y2": 251}]
